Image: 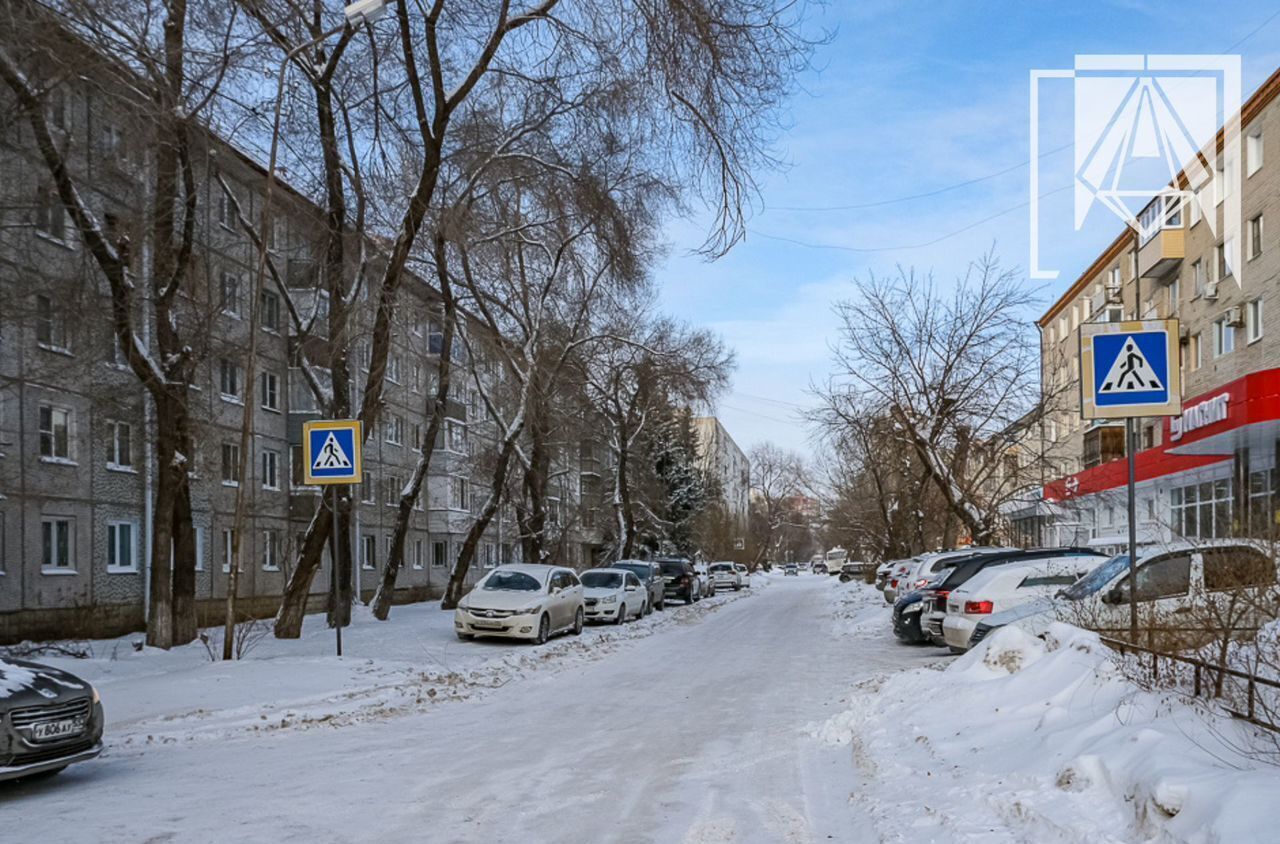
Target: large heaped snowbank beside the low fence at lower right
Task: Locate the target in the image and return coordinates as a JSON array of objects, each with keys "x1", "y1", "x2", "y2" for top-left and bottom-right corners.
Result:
[{"x1": 810, "y1": 624, "x2": 1280, "y2": 841}]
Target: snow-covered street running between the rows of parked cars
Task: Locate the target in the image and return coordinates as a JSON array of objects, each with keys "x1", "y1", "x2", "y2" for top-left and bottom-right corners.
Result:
[{"x1": 0, "y1": 576, "x2": 922, "y2": 844}]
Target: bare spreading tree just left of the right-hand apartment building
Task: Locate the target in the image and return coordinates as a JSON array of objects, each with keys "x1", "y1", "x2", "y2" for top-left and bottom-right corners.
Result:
[{"x1": 819, "y1": 255, "x2": 1039, "y2": 543}]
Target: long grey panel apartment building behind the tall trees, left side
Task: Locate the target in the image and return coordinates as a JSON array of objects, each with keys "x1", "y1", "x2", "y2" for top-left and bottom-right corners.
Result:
[{"x1": 0, "y1": 18, "x2": 565, "y2": 643}]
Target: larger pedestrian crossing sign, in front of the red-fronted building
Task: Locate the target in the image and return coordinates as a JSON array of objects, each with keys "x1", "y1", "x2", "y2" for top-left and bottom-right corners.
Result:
[{"x1": 1080, "y1": 319, "x2": 1183, "y2": 419}]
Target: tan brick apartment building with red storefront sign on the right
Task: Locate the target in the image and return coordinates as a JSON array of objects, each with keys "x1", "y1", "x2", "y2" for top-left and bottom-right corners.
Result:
[{"x1": 1037, "y1": 70, "x2": 1280, "y2": 548}]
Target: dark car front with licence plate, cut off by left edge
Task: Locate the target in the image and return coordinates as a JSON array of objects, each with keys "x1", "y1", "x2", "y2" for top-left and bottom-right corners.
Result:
[{"x1": 0, "y1": 660, "x2": 102, "y2": 780}]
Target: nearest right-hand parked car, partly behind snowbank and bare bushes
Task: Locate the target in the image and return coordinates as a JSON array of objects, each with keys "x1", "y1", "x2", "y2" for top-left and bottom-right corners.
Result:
[{"x1": 969, "y1": 539, "x2": 1276, "y2": 647}]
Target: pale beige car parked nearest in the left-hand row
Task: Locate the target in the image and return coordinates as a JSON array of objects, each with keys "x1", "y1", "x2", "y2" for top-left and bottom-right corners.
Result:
[{"x1": 453, "y1": 564, "x2": 586, "y2": 644}]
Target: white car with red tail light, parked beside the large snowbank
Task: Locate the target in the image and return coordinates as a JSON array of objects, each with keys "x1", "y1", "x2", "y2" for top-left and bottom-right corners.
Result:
[{"x1": 942, "y1": 557, "x2": 1092, "y2": 653}]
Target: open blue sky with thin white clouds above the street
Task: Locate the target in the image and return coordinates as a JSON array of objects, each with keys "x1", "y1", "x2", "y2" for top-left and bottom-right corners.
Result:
[{"x1": 657, "y1": 0, "x2": 1280, "y2": 461}]
